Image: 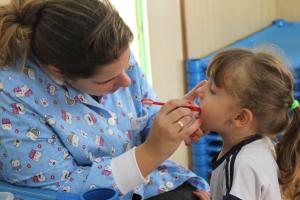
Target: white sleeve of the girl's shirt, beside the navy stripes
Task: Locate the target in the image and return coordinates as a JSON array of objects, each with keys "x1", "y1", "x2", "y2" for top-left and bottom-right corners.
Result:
[{"x1": 230, "y1": 138, "x2": 280, "y2": 199}]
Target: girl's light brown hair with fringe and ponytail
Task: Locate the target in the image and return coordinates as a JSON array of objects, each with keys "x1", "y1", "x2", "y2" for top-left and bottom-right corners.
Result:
[{"x1": 207, "y1": 49, "x2": 300, "y2": 199}]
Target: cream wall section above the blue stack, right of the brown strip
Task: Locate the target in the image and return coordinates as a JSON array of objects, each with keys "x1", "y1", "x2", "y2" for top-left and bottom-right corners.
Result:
[{"x1": 184, "y1": 0, "x2": 275, "y2": 58}]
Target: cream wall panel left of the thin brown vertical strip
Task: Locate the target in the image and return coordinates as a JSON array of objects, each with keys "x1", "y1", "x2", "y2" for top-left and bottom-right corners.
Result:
[{"x1": 147, "y1": 0, "x2": 188, "y2": 167}]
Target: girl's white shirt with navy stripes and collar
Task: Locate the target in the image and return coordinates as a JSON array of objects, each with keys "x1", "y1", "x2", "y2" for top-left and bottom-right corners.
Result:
[{"x1": 211, "y1": 138, "x2": 281, "y2": 200}]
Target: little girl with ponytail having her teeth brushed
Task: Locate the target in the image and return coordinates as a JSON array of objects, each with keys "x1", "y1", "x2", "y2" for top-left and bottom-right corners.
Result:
[{"x1": 192, "y1": 49, "x2": 300, "y2": 200}]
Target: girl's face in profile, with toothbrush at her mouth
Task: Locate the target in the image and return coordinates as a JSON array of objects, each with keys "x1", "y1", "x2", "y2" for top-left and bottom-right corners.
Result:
[{"x1": 197, "y1": 80, "x2": 238, "y2": 134}]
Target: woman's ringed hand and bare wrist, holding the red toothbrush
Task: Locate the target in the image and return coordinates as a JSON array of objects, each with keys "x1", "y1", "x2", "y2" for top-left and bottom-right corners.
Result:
[{"x1": 136, "y1": 99, "x2": 200, "y2": 176}]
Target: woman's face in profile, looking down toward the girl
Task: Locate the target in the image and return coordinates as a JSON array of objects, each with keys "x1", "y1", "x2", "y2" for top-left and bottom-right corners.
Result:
[{"x1": 66, "y1": 48, "x2": 131, "y2": 96}]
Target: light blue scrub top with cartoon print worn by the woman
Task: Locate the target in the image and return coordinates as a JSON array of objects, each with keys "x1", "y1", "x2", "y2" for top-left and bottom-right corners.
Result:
[{"x1": 0, "y1": 55, "x2": 209, "y2": 199}]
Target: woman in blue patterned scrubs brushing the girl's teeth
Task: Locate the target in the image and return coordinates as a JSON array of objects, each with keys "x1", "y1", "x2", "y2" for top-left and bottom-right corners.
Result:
[{"x1": 0, "y1": 0, "x2": 208, "y2": 199}]
